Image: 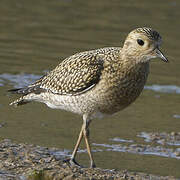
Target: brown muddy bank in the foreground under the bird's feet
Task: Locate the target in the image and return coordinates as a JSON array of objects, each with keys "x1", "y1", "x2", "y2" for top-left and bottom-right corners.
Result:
[{"x1": 0, "y1": 139, "x2": 175, "y2": 180}]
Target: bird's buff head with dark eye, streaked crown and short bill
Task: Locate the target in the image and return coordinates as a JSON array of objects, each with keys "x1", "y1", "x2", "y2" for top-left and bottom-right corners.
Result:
[{"x1": 122, "y1": 27, "x2": 168, "y2": 62}]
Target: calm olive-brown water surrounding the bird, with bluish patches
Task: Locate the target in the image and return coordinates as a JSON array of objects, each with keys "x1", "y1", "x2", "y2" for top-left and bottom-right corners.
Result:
[{"x1": 0, "y1": 0, "x2": 180, "y2": 177}]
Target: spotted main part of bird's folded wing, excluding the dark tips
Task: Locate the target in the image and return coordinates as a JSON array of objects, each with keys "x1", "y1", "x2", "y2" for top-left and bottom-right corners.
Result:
[{"x1": 38, "y1": 49, "x2": 103, "y2": 95}]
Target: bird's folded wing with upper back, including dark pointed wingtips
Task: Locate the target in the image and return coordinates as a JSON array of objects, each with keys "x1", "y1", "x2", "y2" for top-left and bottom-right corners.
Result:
[{"x1": 11, "y1": 48, "x2": 120, "y2": 95}]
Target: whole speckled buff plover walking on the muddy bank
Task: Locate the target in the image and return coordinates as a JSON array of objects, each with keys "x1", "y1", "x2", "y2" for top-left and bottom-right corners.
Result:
[{"x1": 9, "y1": 27, "x2": 168, "y2": 168}]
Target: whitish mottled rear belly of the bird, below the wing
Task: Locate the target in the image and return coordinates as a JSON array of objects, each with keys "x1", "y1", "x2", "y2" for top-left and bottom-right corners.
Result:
[{"x1": 27, "y1": 93, "x2": 98, "y2": 117}]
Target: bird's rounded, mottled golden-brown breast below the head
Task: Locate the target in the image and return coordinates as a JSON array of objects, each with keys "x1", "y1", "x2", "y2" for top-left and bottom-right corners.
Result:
[{"x1": 94, "y1": 64, "x2": 149, "y2": 114}]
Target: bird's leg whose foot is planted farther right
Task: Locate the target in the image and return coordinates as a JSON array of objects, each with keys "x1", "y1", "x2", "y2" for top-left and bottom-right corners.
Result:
[{"x1": 83, "y1": 115, "x2": 96, "y2": 168}]
